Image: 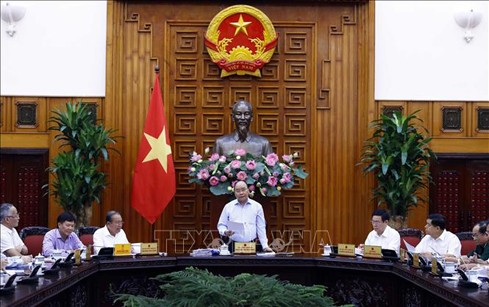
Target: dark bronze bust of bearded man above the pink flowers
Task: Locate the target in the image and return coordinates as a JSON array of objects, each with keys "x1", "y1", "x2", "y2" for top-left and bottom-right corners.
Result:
[{"x1": 214, "y1": 100, "x2": 273, "y2": 157}]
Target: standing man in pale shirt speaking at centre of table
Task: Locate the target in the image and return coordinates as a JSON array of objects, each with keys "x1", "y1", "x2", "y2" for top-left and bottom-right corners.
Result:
[{"x1": 217, "y1": 181, "x2": 272, "y2": 252}]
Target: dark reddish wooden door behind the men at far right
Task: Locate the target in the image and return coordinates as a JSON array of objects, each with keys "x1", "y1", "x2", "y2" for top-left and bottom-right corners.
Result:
[{"x1": 430, "y1": 156, "x2": 489, "y2": 233}]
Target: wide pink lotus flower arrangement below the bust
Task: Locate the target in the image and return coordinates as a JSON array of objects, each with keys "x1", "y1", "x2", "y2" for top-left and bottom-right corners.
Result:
[{"x1": 188, "y1": 148, "x2": 308, "y2": 197}]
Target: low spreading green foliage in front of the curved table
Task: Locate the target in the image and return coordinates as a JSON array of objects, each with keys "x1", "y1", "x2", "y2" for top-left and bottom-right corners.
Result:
[{"x1": 116, "y1": 267, "x2": 335, "y2": 307}]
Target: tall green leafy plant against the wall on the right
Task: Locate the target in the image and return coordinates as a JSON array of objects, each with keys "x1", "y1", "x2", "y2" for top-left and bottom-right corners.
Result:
[{"x1": 361, "y1": 110, "x2": 436, "y2": 228}]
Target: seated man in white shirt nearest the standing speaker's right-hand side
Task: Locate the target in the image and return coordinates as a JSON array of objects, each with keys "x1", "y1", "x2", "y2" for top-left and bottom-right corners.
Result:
[{"x1": 360, "y1": 209, "x2": 401, "y2": 255}]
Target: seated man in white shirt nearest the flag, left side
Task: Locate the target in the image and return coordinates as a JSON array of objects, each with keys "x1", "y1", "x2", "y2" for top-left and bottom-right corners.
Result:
[{"x1": 93, "y1": 211, "x2": 129, "y2": 254}]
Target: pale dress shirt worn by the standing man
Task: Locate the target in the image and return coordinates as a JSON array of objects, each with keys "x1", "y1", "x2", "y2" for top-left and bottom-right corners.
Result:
[{"x1": 217, "y1": 198, "x2": 268, "y2": 248}]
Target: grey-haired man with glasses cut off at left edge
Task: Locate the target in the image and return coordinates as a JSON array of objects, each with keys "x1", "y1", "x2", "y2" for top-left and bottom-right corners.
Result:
[{"x1": 0, "y1": 203, "x2": 29, "y2": 257}]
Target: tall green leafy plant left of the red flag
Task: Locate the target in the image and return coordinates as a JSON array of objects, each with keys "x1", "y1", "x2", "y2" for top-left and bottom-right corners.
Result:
[{"x1": 48, "y1": 102, "x2": 116, "y2": 227}]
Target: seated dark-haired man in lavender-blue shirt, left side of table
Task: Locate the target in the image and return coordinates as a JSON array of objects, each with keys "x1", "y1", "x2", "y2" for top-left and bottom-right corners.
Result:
[{"x1": 42, "y1": 212, "x2": 83, "y2": 257}]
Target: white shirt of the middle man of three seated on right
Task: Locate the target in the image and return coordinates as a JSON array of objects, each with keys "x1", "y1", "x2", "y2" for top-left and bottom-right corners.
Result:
[{"x1": 414, "y1": 229, "x2": 462, "y2": 257}]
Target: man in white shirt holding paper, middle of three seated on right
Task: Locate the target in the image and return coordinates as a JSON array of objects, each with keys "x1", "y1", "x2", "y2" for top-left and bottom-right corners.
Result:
[{"x1": 414, "y1": 214, "x2": 462, "y2": 259}]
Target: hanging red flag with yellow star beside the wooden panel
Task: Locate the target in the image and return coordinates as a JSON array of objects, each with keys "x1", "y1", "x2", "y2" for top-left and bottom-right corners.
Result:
[{"x1": 132, "y1": 69, "x2": 176, "y2": 224}]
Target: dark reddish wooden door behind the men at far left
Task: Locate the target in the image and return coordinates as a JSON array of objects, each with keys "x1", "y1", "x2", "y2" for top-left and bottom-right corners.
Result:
[{"x1": 0, "y1": 150, "x2": 48, "y2": 231}]
